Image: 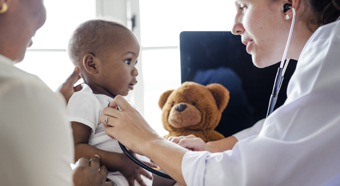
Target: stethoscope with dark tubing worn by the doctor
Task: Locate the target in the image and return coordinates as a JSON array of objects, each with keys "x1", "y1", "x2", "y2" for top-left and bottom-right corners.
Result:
[{"x1": 115, "y1": 4, "x2": 296, "y2": 180}]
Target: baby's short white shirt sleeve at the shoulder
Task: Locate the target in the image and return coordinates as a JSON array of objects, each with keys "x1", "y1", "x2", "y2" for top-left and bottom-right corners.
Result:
[{"x1": 67, "y1": 91, "x2": 102, "y2": 134}]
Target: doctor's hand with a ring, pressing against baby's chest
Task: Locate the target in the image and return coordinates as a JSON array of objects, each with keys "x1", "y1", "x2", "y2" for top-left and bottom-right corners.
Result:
[{"x1": 100, "y1": 95, "x2": 164, "y2": 155}]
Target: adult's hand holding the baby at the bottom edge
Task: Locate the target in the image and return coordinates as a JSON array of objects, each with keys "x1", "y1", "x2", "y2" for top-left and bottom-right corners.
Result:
[{"x1": 73, "y1": 156, "x2": 113, "y2": 186}]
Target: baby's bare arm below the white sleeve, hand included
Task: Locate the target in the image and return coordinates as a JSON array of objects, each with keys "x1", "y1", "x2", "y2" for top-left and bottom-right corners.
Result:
[{"x1": 72, "y1": 122, "x2": 152, "y2": 185}]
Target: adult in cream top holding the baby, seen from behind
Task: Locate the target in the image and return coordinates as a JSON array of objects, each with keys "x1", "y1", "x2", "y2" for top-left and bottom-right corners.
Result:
[{"x1": 0, "y1": 0, "x2": 112, "y2": 186}]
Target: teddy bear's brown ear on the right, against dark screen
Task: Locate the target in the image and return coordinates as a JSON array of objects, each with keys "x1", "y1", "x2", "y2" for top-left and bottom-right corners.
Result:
[{"x1": 207, "y1": 83, "x2": 229, "y2": 111}]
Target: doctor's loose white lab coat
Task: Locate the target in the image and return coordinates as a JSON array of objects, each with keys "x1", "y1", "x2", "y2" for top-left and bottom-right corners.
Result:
[{"x1": 182, "y1": 21, "x2": 340, "y2": 186}]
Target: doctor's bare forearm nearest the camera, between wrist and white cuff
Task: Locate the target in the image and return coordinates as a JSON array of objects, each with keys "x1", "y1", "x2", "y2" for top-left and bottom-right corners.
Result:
[{"x1": 144, "y1": 138, "x2": 188, "y2": 185}]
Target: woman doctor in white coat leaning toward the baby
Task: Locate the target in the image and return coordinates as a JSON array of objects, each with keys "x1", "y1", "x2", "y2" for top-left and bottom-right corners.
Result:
[{"x1": 93, "y1": 0, "x2": 340, "y2": 186}]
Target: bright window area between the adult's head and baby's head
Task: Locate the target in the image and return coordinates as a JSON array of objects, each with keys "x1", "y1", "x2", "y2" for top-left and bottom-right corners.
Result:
[{"x1": 17, "y1": 0, "x2": 96, "y2": 90}]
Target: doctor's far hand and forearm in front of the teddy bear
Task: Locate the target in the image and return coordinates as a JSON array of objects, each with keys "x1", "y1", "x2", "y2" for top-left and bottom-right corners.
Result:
[{"x1": 168, "y1": 134, "x2": 238, "y2": 153}]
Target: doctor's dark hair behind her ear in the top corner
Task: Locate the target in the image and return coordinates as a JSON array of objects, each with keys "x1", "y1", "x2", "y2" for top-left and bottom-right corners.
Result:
[{"x1": 307, "y1": 0, "x2": 340, "y2": 26}]
